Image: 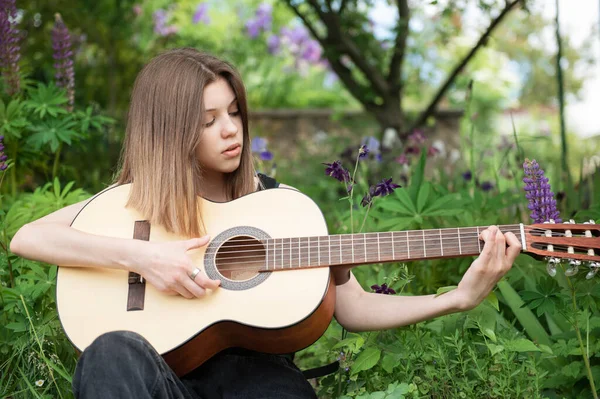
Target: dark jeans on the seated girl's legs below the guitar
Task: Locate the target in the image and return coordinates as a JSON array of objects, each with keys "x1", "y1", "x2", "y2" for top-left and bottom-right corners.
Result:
[{"x1": 73, "y1": 331, "x2": 317, "y2": 399}]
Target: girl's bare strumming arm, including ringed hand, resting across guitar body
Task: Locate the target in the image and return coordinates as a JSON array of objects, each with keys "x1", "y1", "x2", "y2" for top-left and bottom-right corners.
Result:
[{"x1": 10, "y1": 199, "x2": 219, "y2": 298}]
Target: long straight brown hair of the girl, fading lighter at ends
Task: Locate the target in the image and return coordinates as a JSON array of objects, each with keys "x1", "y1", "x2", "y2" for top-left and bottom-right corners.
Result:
[{"x1": 117, "y1": 48, "x2": 256, "y2": 237}]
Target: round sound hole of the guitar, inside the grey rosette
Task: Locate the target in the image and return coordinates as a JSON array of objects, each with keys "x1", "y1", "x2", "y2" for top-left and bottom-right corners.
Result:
[{"x1": 215, "y1": 236, "x2": 266, "y2": 281}]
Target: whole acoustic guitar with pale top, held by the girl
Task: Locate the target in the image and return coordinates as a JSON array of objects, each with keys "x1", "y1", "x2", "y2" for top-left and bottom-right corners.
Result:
[{"x1": 56, "y1": 185, "x2": 600, "y2": 376}]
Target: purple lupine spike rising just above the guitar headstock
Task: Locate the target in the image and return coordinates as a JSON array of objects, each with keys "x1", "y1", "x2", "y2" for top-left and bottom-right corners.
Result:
[{"x1": 523, "y1": 159, "x2": 562, "y2": 223}]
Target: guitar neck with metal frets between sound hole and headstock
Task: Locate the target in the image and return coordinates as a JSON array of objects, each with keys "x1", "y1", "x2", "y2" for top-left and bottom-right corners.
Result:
[{"x1": 263, "y1": 224, "x2": 524, "y2": 271}]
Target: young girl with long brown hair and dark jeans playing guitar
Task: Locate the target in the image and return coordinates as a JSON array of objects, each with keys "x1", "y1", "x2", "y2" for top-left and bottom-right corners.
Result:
[{"x1": 11, "y1": 48, "x2": 521, "y2": 398}]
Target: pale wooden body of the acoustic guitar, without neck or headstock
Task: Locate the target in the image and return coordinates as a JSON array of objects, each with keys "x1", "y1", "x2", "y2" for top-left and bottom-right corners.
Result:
[{"x1": 56, "y1": 185, "x2": 335, "y2": 375}]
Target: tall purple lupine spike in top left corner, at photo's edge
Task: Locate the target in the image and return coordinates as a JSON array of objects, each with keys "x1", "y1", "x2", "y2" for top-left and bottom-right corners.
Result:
[{"x1": 0, "y1": 0, "x2": 21, "y2": 96}]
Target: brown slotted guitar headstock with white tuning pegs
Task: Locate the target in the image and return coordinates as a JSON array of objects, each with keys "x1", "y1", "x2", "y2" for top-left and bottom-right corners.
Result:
[{"x1": 525, "y1": 220, "x2": 600, "y2": 279}]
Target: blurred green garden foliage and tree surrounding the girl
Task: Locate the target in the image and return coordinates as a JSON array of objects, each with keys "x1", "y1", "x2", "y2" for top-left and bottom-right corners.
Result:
[{"x1": 0, "y1": 0, "x2": 600, "y2": 398}]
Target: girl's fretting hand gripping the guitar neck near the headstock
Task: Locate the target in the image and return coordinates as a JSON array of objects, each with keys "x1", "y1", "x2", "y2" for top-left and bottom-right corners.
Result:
[{"x1": 454, "y1": 226, "x2": 521, "y2": 310}]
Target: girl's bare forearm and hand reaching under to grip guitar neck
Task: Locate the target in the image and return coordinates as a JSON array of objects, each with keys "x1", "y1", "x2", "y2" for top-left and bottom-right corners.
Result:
[{"x1": 335, "y1": 226, "x2": 521, "y2": 331}]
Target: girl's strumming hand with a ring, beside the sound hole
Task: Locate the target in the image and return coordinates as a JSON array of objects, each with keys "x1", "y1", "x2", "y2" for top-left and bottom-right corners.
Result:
[{"x1": 131, "y1": 236, "x2": 221, "y2": 299}]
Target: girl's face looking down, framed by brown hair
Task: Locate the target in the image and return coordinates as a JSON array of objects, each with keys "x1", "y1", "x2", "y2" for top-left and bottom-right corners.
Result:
[{"x1": 197, "y1": 78, "x2": 244, "y2": 178}]
